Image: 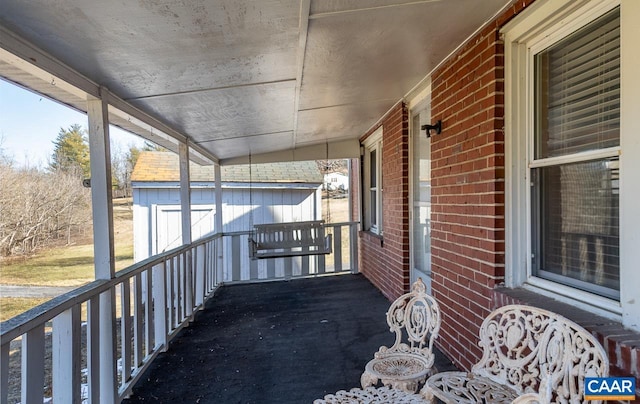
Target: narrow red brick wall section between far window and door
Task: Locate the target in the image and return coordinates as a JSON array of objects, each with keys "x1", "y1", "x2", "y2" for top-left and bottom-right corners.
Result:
[{"x1": 359, "y1": 103, "x2": 409, "y2": 300}]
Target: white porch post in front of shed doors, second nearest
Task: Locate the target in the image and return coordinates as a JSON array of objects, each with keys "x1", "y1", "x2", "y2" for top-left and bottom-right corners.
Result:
[{"x1": 178, "y1": 142, "x2": 193, "y2": 317}]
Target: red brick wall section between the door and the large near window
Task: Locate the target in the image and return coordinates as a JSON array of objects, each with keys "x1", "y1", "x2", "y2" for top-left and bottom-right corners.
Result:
[{"x1": 431, "y1": 1, "x2": 531, "y2": 369}]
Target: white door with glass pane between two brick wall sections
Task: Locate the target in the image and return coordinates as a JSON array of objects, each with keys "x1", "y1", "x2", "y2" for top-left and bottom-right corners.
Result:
[{"x1": 411, "y1": 100, "x2": 431, "y2": 291}]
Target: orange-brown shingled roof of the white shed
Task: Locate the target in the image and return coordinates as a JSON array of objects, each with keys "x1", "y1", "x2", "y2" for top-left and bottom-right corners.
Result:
[{"x1": 131, "y1": 151, "x2": 322, "y2": 184}]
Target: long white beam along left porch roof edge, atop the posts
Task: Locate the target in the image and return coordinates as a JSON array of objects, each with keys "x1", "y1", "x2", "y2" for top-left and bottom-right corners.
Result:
[{"x1": 0, "y1": 25, "x2": 217, "y2": 164}]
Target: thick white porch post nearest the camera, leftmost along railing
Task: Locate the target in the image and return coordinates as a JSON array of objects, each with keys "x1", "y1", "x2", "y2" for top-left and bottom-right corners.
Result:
[{"x1": 87, "y1": 88, "x2": 117, "y2": 403}]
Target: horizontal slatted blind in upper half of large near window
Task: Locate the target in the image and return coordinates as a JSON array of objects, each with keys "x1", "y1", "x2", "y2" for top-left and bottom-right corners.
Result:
[{"x1": 535, "y1": 9, "x2": 620, "y2": 158}]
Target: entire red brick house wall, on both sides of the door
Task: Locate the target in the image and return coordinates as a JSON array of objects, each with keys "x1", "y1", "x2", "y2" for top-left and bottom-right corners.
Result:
[{"x1": 352, "y1": 0, "x2": 640, "y2": 388}]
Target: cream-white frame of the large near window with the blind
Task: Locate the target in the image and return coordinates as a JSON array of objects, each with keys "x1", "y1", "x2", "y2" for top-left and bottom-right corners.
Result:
[{"x1": 501, "y1": 0, "x2": 640, "y2": 330}]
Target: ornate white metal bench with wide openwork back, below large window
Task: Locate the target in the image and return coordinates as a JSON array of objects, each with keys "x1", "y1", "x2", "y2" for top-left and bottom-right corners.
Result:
[{"x1": 421, "y1": 305, "x2": 609, "y2": 404}]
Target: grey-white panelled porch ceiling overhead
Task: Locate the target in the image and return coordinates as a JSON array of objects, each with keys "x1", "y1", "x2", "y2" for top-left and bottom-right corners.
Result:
[{"x1": 0, "y1": 0, "x2": 512, "y2": 161}]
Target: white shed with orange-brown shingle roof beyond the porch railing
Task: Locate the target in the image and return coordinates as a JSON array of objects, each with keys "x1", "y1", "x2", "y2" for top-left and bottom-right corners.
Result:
[{"x1": 131, "y1": 152, "x2": 323, "y2": 262}]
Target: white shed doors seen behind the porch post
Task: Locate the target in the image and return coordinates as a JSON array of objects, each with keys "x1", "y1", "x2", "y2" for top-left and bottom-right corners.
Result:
[{"x1": 151, "y1": 205, "x2": 215, "y2": 255}]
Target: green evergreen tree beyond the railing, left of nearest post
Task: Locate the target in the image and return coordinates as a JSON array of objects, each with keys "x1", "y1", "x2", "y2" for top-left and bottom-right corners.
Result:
[{"x1": 49, "y1": 124, "x2": 91, "y2": 178}]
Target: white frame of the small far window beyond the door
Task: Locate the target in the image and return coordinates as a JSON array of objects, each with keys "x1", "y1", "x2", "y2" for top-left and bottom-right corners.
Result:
[{"x1": 362, "y1": 126, "x2": 383, "y2": 236}]
